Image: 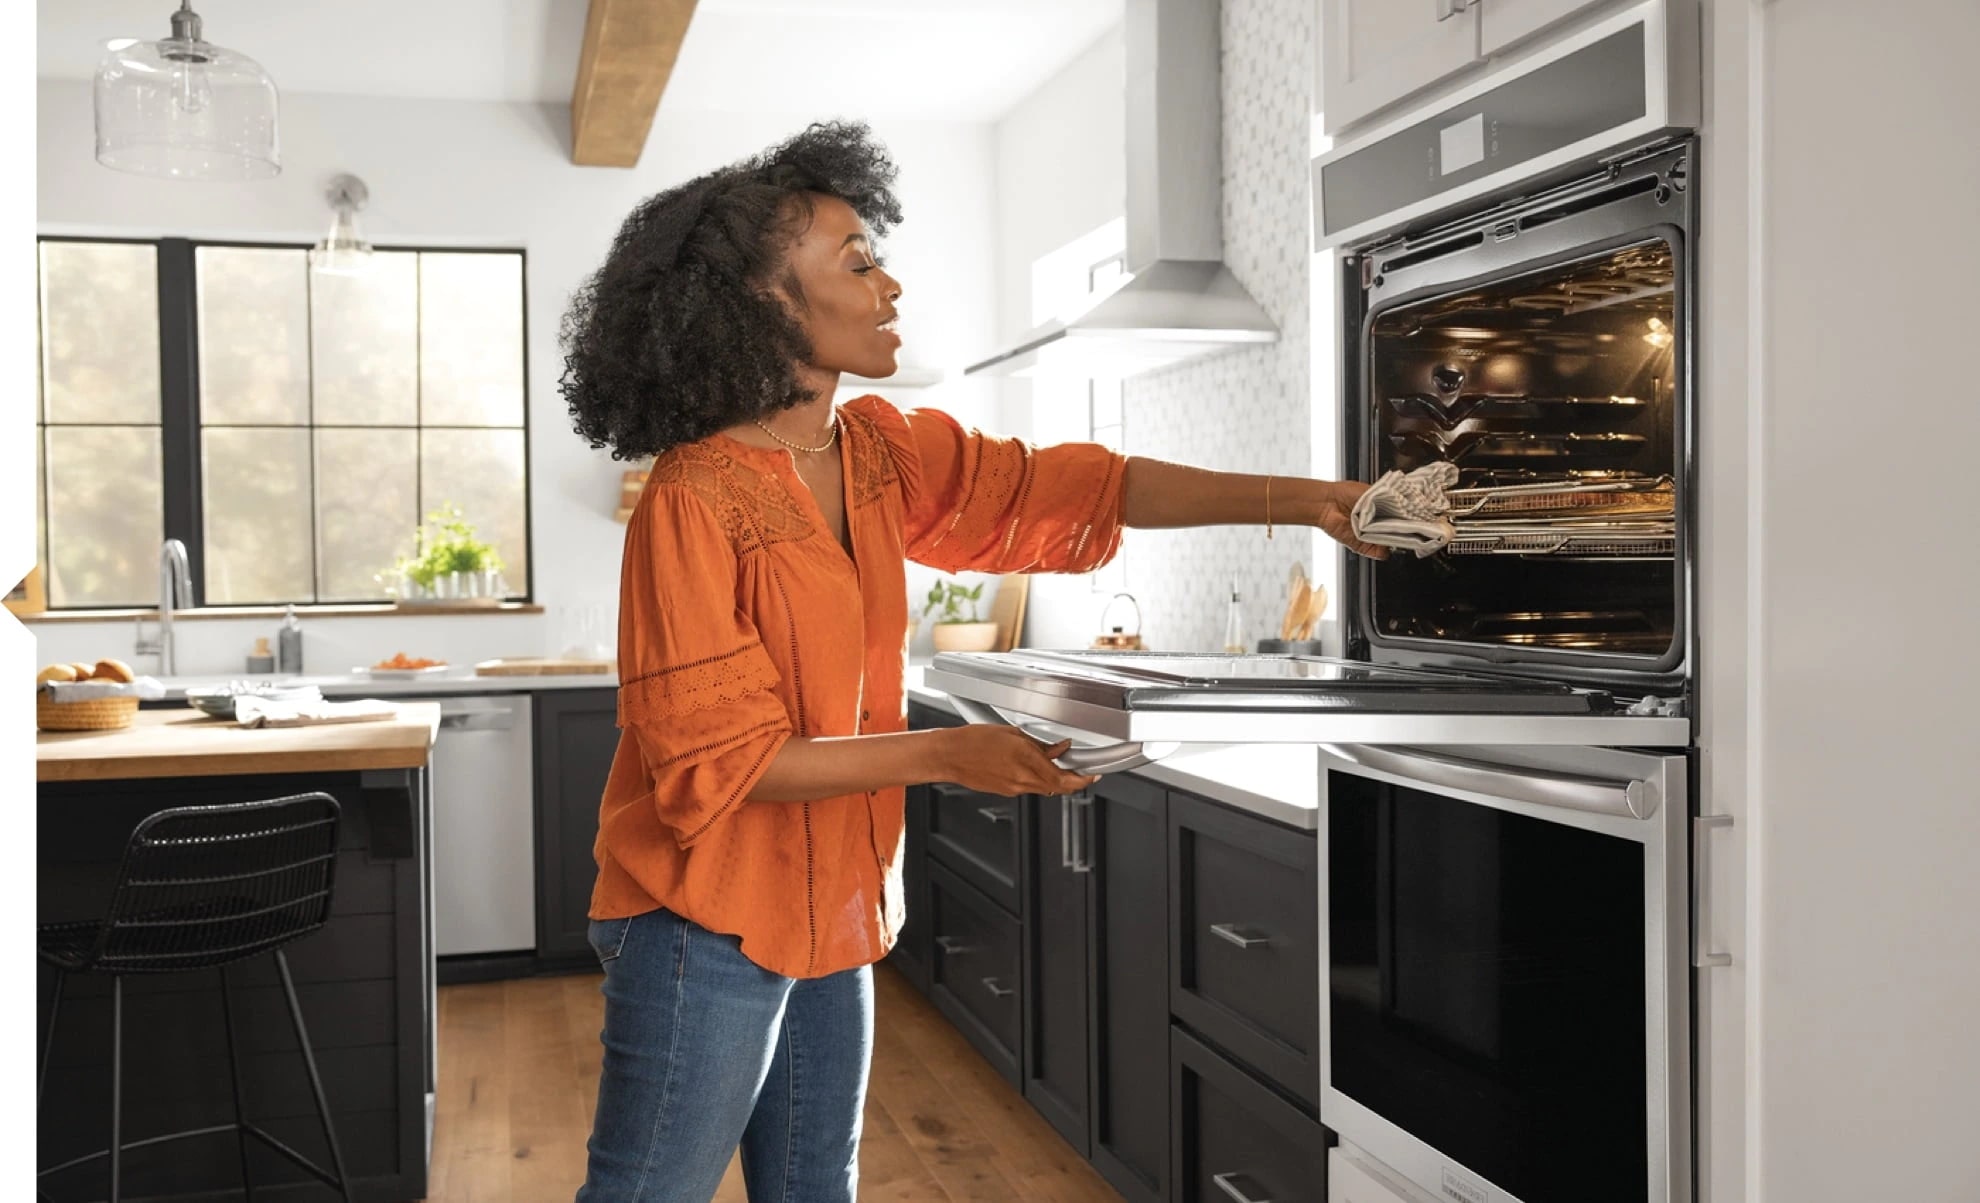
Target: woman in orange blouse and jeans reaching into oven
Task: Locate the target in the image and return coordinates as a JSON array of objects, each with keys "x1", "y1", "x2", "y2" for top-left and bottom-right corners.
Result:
[{"x1": 562, "y1": 125, "x2": 1386, "y2": 1203}]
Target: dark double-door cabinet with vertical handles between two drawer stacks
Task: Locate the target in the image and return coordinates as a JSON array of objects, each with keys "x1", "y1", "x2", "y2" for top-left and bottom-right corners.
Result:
[{"x1": 1024, "y1": 776, "x2": 1170, "y2": 1203}]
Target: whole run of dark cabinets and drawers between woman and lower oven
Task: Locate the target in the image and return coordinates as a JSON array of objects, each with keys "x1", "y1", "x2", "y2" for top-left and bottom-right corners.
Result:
[{"x1": 891, "y1": 704, "x2": 1327, "y2": 1203}]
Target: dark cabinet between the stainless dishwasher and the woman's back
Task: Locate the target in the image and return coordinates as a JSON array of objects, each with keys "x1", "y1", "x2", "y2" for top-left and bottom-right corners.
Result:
[{"x1": 535, "y1": 689, "x2": 620, "y2": 966}]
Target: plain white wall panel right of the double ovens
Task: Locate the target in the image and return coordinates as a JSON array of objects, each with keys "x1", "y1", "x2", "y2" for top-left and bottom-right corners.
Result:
[{"x1": 1750, "y1": 0, "x2": 1980, "y2": 1203}]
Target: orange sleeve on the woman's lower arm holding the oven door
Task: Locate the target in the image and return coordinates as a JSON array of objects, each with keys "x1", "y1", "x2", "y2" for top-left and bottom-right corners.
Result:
[{"x1": 618, "y1": 483, "x2": 794, "y2": 847}]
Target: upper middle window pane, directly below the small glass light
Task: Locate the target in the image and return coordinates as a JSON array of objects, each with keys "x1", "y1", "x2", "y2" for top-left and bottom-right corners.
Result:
[{"x1": 309, "y1": 251, "x2": 420, "y2": 425}]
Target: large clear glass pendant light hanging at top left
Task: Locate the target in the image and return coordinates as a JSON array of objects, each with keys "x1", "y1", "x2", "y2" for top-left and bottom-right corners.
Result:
[{"x1": 97, "y1": 0, "x2": 281, "y2": 180}]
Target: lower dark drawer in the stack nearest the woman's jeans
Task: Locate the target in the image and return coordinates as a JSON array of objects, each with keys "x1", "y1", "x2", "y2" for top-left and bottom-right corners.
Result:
[{"x1": 929, "y1": 863, "x2": 1024, "y2": 1086}]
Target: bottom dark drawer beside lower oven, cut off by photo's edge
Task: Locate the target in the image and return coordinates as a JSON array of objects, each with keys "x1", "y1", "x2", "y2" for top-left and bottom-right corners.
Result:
[{"x1": 1168, "y1": 1031, "x2": 1327, "y2": 1203}]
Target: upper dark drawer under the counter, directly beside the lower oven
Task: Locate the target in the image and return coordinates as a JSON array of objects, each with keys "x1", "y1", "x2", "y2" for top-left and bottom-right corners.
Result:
[{"x1": 1168, "y1": 793, "x2": 1321, "y2": 1106}]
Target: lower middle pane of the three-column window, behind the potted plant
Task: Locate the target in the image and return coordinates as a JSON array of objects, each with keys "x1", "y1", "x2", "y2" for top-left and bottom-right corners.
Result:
[{"x1": 317, "y1": 429, "x2": 420, "y2": 602}]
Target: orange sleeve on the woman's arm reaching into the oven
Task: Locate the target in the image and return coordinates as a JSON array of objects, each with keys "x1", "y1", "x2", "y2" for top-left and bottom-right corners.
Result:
[{"x1": 853, "y1": 398, "x2": 1127, "y2": 572}]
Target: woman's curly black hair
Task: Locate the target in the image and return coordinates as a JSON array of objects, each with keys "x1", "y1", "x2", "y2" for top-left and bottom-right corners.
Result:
[{"x1": 558, "y1": 121, "x2": 901, "y2": 459}]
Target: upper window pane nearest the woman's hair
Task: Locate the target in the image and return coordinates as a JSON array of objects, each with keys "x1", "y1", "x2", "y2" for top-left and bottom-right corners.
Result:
[{"x1": 420, "y1": 253, "x2": 523, "y2": 425}]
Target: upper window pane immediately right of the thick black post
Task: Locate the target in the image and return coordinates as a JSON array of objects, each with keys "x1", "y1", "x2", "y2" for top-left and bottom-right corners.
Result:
[{"x1": 194, "y1": 247, "x2": 309, "y2": 425}]
